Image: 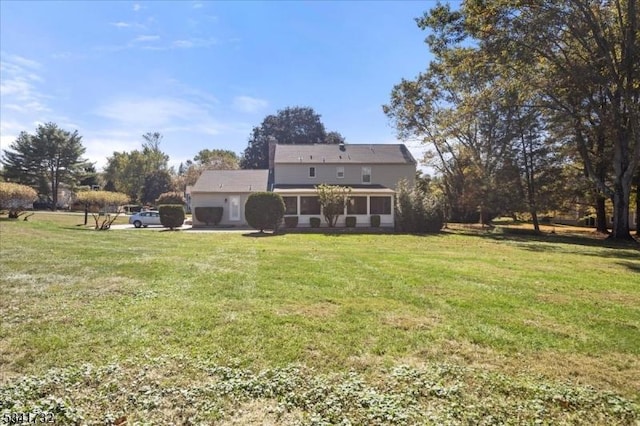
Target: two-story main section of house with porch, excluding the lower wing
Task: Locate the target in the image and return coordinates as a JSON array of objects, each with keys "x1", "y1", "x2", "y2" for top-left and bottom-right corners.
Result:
[{"x1": 270, "y1": 144, "x2": 416, "y2": 227}]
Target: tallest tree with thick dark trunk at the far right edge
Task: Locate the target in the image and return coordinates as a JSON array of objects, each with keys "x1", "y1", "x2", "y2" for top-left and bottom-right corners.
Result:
[{"x1": 460, "y1": 0, "x2": 640, "y2": 239}]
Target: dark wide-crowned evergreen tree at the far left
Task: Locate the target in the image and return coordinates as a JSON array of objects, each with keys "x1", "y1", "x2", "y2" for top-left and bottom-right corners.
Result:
[{"x1": 2, "y1": 123, "x2": 89, "y2": 210}]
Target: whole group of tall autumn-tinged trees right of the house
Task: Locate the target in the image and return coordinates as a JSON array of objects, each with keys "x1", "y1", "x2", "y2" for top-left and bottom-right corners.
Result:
[{"x1": 383, "y1": 0, "x2": 640, "y2": 239}]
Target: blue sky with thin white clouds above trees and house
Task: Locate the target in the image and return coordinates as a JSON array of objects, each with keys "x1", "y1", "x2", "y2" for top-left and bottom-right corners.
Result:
[{"x1": 0, "y1": 0, "x2": 435, "y2": 169}]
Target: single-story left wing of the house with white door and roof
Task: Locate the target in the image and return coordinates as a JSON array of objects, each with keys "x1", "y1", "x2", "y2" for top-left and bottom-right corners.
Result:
[{"x1": 191, "y1": 170, "x2": 269, "y2": 228}]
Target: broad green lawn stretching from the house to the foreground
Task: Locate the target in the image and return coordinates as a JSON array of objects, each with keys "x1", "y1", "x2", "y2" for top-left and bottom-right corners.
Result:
[{"x1": 0, "y1": 214, "x2": 640, "y2": 424}]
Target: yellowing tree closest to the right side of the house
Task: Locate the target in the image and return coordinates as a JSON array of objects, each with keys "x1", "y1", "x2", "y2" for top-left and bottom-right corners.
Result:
[{"x1": 383, "y1": 44, "x2": 522, "y2": 224}]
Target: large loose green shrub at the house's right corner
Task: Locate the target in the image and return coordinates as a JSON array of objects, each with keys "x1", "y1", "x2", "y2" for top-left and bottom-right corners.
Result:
[{"x1": 395, "y1": 181, "x2": 444, "y2": 233}]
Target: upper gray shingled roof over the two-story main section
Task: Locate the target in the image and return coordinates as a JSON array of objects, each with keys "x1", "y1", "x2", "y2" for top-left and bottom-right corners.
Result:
[{"x1": 274, "y1": 144, "x2": 416, "y2": 164}]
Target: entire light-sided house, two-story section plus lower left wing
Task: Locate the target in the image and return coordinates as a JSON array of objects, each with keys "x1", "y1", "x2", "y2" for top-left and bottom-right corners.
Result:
[{"x1": 191, "y1": 144, "x2": 416, "y2": 227}]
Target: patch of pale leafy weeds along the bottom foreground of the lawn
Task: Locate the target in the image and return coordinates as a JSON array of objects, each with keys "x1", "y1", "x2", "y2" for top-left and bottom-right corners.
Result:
[{"x1": 0, "y1": 357, "x2": 640, "y2": 425}]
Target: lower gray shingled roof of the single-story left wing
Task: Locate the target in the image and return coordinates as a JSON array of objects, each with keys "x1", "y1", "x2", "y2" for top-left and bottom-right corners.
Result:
[{"x1": 191, "y1": 170, "x2": 269, "y2": 193}]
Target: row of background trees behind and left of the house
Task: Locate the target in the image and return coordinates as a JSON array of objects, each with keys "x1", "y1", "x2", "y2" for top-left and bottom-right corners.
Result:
[{"x1": 1, "y1": 107, "x2": 344, "y2": 209}]
